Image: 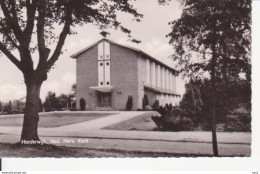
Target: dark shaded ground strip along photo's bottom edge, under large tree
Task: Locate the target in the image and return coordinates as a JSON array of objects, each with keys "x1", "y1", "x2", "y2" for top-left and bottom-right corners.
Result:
[{"x1": 0, "y1": 143, "x2": 214, "y2": 158}]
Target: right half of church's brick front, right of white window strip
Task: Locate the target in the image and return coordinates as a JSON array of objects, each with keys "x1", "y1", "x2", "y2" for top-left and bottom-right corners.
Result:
[{"x1": 110, "y1": 44, "x2": 138, "y2": 110}]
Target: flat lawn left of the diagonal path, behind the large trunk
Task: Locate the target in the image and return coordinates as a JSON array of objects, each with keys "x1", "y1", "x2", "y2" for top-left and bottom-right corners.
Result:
[{"x1": 0, "y1": 113, "x2": 113, "y2": 127}]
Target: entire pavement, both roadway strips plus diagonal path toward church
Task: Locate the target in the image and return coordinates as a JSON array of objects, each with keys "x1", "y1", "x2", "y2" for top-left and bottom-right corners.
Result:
[{"x1": 0, "y1": 112, "x2": 251, "y2": 156}]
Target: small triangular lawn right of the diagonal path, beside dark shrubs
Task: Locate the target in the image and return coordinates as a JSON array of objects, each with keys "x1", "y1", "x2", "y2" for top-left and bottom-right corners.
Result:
[{"x1": 104, "y1": 112, "x2": 158, "y2": 131}]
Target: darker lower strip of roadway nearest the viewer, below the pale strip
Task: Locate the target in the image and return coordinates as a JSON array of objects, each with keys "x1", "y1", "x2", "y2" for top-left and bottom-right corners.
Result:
[{"x1": 0, "y1": 134, "x2": 251, "y2": 156}]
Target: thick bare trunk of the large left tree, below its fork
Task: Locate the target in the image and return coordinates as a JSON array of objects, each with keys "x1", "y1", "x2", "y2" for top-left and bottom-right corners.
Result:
[{"x1": 21, "y1": 80, "x2": 42, "y2": 142}]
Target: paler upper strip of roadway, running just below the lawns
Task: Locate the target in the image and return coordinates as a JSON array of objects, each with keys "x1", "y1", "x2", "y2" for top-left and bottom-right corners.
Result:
[{"x1": 0, "y1": 126, "x2": 251, "y2": 145}]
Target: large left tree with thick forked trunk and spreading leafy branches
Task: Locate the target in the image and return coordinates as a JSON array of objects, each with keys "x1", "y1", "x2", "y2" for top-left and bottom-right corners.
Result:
[{"x1": 0, "y1": 0, "x2": 142, "y2": 140}]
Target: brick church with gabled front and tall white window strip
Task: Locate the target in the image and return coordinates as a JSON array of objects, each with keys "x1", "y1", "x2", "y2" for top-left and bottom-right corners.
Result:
[{"x1": 71, "y1": 38, "x2": 180, "y2": 110}]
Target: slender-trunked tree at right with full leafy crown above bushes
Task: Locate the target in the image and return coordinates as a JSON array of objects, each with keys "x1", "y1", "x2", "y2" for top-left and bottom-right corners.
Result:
[{"x1": 168, "y1": 0, "x2": 251, "y2": 156}]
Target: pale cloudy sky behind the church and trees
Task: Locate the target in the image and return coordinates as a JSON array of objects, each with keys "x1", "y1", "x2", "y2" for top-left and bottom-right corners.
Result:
[{"x1": 0, "y1": 0, "x2": 184, "y2": 102}]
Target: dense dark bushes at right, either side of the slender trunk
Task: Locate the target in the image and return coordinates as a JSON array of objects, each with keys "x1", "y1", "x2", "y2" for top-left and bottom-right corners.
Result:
[{"x1": 180, "y1": 79, "x2": 251, "y2": 125}]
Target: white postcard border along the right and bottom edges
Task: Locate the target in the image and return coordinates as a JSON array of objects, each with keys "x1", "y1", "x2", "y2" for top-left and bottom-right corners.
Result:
[{"x1": 2, "y1": 1, "x2": 260, "y2": 173}]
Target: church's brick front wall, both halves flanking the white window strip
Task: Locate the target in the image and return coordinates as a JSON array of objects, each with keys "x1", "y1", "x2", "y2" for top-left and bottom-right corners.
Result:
[{"x1": 76, "y1": 44, "x2": 138, "y2": 110}]
